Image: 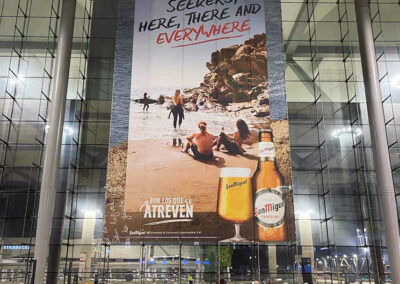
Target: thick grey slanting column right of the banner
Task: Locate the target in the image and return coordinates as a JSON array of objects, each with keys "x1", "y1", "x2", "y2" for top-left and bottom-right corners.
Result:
[{"x1": 355, "y1": 0, "x2": 400, "y2": 283}]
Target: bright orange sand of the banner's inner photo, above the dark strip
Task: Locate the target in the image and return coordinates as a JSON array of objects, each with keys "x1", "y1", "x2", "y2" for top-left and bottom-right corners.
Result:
[{"x1": 125, "y1": 139, "x2": 258, "y2": 212}]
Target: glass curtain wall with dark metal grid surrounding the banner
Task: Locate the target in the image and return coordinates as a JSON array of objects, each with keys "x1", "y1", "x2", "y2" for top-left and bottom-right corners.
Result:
[{"x1": 0, "y1": 0, "x2": 400, "y2": 283}]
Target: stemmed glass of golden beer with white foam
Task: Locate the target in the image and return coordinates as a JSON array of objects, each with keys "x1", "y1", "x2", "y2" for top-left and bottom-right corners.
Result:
[{"x1": 217, "y1": 168, "x2": 253, "y2": 243}]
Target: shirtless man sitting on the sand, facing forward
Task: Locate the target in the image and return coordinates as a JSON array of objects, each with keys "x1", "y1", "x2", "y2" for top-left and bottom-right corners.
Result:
[{"x1": 182, "y1": 121, "x2": 214, "y2": 160}]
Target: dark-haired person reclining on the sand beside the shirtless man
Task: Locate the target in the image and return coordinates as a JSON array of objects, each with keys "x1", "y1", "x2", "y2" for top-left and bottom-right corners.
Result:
[{"x1": 214, "y1": 119, "x2": 250, "y2": 154}]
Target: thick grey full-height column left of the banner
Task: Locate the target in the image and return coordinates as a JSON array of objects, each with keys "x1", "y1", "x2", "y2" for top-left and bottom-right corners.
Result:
[{"x1": 34, "y1": 0, "x2": 76, "y2": 284}]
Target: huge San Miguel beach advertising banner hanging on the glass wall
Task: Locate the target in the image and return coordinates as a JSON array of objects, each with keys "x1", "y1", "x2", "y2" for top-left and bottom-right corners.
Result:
[{"x1": 104, "y1": 0, "x2": 295, "y2": 243}]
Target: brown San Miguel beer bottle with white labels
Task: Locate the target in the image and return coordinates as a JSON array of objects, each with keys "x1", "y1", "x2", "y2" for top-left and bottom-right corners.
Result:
[{"x1": 253, "y1": 130, "x2": 286, "y2": 242}]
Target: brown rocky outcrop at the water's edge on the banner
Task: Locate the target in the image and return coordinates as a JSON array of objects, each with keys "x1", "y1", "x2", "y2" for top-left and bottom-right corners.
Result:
[{"x1": 183, "y1": 34, "x2": 269, "y2": 117}]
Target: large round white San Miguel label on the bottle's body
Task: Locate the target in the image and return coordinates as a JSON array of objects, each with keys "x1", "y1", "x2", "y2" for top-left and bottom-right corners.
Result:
[{"x1": 254, "y1": 187, "x2": 285, "y2": 227}]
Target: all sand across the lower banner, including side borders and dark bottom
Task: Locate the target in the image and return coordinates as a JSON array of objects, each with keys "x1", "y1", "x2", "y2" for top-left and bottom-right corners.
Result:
[{"x1": 103, "y1": 120, "x2": 296, "y2": 243}]
